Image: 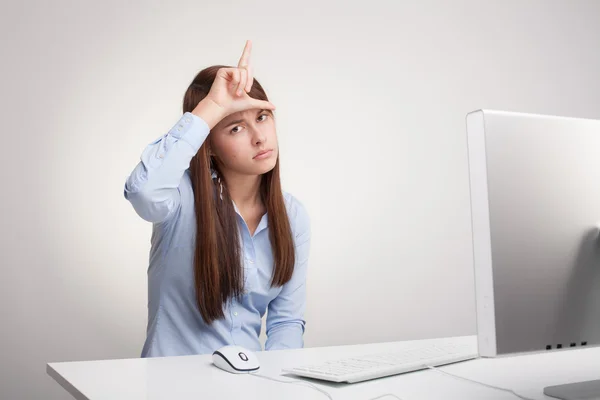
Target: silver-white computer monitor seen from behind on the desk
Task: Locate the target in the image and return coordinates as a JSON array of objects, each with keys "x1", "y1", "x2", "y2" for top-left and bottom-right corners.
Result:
[{"x1": 466, "y1": 110, "x2": 600, "y2": 398}]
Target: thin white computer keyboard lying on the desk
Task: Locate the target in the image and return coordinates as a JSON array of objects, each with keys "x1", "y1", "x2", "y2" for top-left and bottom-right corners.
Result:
[{"x1": 282, "y1": 341, "x2": 479, "y2": 383}]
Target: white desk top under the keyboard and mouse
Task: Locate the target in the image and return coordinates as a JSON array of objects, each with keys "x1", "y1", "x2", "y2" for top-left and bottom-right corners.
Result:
[{"x1": 47, "y1": 336, "x2": 600, "y2": 400}]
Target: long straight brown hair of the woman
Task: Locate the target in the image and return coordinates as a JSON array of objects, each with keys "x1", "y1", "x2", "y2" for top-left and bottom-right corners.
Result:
[{"x1": 183, "y1": 65, "x2": 295, "y2": 324}]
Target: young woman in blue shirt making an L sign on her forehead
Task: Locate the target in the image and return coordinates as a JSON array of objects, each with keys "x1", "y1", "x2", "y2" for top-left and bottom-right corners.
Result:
[{"x1": 124, "y1": 41, "x2": 310, "y2": 357}]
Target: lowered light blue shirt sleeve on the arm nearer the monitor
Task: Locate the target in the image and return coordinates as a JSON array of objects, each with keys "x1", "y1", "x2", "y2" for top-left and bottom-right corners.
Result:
[{"x1": 265, "y1": 203, "x2": 311, "y2": 350}]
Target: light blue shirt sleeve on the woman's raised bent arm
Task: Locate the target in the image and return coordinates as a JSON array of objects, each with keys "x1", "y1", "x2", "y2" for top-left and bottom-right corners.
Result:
[{"x1": 123, "y1": 112, "x2": 210, "y2": 222}]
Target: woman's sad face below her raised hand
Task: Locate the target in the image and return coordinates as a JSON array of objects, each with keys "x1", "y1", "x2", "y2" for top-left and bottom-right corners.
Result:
[{"x1": 210, "y1": 109, "x2": 279, "y2": 175}]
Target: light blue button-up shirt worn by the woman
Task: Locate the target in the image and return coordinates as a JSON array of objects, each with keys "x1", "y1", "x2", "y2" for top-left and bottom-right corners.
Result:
[{"x1": 124, "y1": 112, "x2": 311, "y2": 357}]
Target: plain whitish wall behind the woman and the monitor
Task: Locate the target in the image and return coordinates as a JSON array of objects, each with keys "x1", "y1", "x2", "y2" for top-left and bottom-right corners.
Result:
[{"x1": 0, "y1": 0, "x2": 600, "y2": 399}]
